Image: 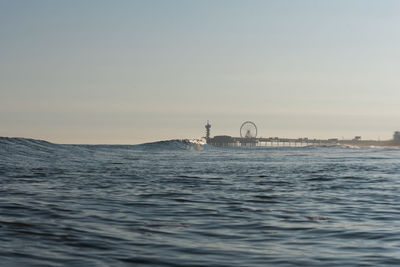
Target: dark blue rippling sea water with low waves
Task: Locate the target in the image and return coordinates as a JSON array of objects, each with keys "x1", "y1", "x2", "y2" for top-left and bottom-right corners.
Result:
[{"x1": 0, "y1": 138, "x2": 400, "y2": 266}]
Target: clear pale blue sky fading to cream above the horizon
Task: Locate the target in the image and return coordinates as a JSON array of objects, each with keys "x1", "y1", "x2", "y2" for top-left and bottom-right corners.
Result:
[{"x1": 0, "y1": 0, "x2": 400, "y2": 144}]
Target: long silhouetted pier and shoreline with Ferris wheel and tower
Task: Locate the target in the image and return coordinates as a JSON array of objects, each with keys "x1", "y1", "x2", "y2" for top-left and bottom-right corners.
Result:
[{"x1": 205, "y1": 121, "x2": 400, "y2": 147}]
